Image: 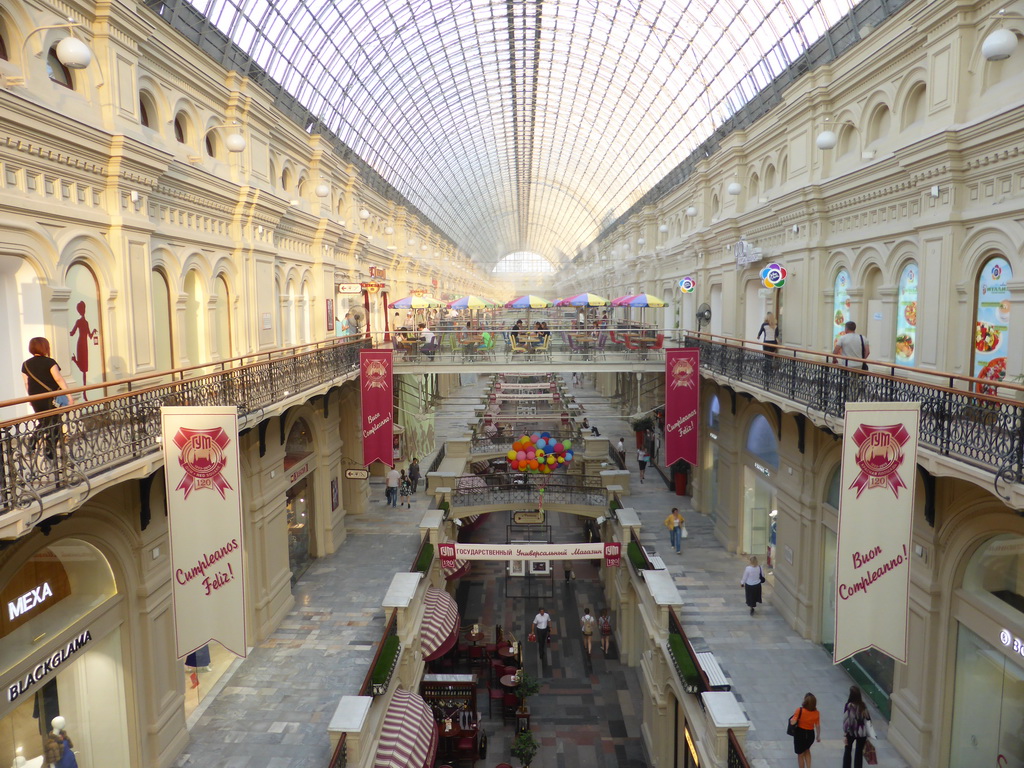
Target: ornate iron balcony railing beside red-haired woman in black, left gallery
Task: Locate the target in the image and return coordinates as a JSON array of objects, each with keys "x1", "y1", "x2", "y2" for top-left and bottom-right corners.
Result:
[{"x1": 0, "y1": 340, "x2": 368, "y2": 521}]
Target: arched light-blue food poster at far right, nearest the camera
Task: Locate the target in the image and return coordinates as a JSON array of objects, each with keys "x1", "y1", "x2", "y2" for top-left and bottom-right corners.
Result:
[{"x1": 973, "y1": 256, "x2": 1014, "y2": 394}]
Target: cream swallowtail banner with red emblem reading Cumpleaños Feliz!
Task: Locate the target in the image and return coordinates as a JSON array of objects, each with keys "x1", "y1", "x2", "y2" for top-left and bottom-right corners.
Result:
[{"x1": 161, "y1": 407, "x2": 246, "y2": 658}]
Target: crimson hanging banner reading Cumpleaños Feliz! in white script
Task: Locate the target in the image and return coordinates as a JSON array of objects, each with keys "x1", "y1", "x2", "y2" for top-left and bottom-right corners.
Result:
[{"x1": 665, "y1": 348, "x2": 700, "y2": 467}]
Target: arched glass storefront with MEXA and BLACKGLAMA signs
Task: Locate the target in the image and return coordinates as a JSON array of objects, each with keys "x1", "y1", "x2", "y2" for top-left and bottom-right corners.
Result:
[{"x1": 0, "y1": 539, "x2": 130, "y2": 768}]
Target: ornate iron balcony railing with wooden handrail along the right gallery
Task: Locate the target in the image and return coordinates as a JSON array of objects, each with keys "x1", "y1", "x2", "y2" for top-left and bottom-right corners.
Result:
[{"x1": 686, "y1": 336, "x2": 1024, "y2": 498}]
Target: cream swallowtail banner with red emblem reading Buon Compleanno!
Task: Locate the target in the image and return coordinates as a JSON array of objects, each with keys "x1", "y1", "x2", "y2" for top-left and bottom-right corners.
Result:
[{"x1": 834, "y1": 402, "x2": 921, "y2": 664}]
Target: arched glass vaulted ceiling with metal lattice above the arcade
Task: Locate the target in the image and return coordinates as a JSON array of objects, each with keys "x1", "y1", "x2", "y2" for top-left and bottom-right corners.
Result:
[{"x1": 190, "y1": 0, "x2": 854, "y2": 264}]
